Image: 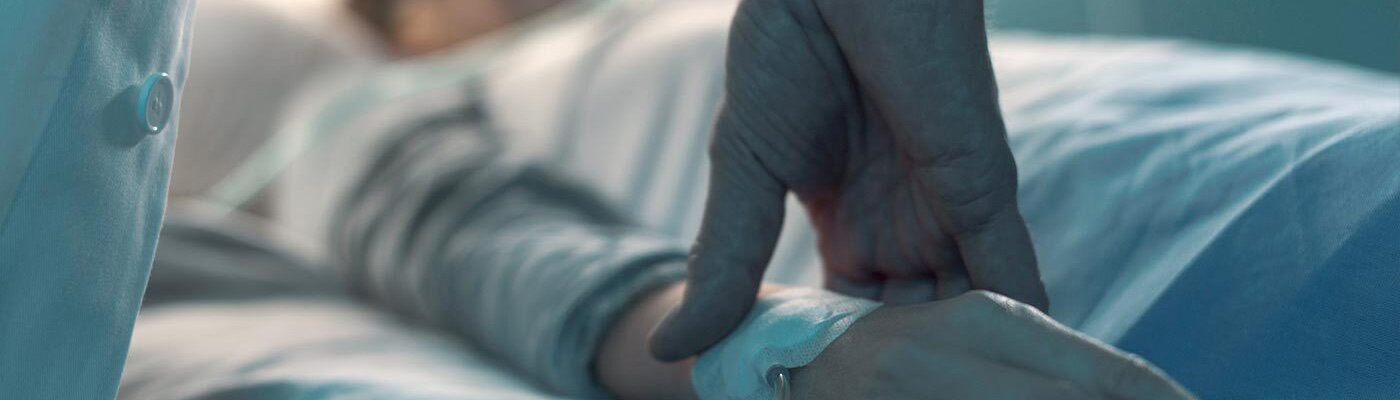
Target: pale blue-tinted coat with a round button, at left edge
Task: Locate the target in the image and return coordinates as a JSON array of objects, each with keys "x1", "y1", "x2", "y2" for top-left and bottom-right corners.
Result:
[{"x1": 0, "y1": 0, "x2": 193, "y2": 399}]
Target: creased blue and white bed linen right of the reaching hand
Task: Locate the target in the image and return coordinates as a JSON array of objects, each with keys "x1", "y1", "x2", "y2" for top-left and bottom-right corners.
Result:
[{"x1": 995, "y1": 36, "x2": 1400, "y2": 399}]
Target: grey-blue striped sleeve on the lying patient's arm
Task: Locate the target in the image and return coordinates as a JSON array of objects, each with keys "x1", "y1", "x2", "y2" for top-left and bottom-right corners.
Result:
[{"x1": 330, "y1": 115, "x2": 686, "y2": 399}]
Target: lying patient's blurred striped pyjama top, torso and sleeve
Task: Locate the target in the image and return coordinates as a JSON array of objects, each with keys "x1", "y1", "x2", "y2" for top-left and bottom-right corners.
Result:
[{"x1": 277, "y1": 1, "x2": 818, "y2": 397}]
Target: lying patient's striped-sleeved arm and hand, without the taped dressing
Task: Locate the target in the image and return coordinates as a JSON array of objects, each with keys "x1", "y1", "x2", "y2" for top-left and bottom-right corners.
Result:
[{"x1": 332, "y1": 113, "x2": 1183, "y2": 399}]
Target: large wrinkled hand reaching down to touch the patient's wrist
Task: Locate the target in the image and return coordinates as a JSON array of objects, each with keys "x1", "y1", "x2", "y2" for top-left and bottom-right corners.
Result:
[{"x1": 651, "y1": 0, "x2": 1047, "y2": 361}]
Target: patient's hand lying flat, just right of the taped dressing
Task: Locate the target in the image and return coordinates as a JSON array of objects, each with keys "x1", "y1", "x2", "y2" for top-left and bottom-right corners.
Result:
[{"x1": 792, "y1": 291, "x2": 1193, "y2": 400}]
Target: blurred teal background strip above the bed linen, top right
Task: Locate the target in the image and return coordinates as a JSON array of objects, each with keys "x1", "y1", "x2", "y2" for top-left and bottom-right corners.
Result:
[{"x1": 987, "y1": 0, "x2": 1400, "y2": 73}]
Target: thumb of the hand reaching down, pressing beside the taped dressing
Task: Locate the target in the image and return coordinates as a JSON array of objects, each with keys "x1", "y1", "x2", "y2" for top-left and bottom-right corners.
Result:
[{"x1": 650, "y1": 115, "x2": 787, "y2": 362}]
